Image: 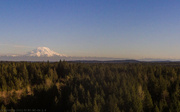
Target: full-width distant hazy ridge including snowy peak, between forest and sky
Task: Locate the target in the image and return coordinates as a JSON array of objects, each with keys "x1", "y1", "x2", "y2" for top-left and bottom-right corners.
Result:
[{"x1": 0, "y1": 47, "x2": 176, "y2": 63}]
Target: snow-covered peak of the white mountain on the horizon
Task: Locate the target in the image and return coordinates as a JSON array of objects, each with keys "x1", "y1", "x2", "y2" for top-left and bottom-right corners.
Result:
[{"x1": 26, "y1": 47, "x2": 65, "y2": 57}]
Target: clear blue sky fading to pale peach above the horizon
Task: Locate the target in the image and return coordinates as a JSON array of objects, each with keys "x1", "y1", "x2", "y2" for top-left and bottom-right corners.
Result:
[{"x1": 0, "y1": 0, "x2": 180, "y2": 59}]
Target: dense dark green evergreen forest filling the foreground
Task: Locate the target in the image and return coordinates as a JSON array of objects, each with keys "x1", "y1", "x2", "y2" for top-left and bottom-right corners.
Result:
[{"x1": 0, "y1": 60, "x2": 180, "y2": 112}]
